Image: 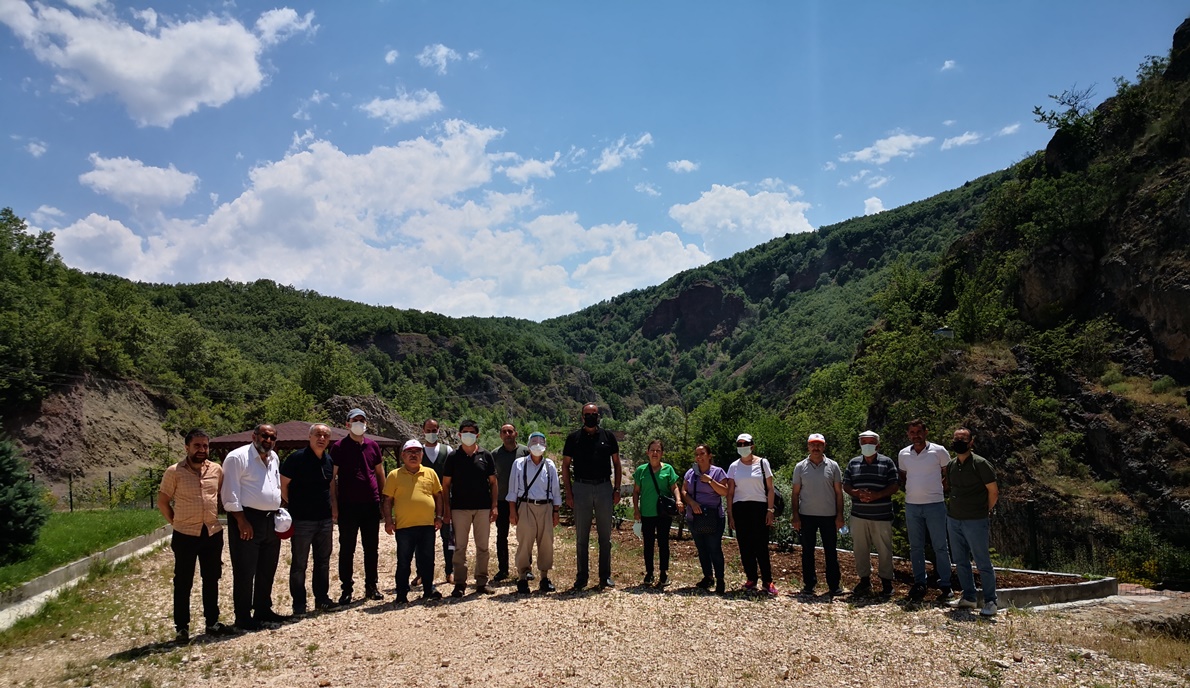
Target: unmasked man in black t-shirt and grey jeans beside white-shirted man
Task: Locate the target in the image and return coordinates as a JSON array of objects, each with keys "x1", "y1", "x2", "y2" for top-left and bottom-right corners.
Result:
[{"x1": 281, "y1": 424, "x2": 336, "y2": 617}]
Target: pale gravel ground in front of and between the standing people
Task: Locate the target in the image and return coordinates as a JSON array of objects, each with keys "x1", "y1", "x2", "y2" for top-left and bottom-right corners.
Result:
[{"x1": 0, "y1": 521, "x2": 1190, "y2": 688}]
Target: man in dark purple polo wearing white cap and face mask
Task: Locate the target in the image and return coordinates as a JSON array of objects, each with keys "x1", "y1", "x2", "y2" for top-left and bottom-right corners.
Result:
[{"x1": 331, "y1": 408, "x2": 384, "y2": 605}]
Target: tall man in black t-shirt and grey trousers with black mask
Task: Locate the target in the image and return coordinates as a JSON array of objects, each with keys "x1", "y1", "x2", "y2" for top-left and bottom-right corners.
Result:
[{"x1": 562, "y1": 404, "x2": 621, "y2": 590}]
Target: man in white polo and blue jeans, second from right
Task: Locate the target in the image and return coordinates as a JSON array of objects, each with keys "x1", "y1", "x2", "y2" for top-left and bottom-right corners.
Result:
[{"x1": 897, "y1": 419, "x2": 951, "y2": 602}]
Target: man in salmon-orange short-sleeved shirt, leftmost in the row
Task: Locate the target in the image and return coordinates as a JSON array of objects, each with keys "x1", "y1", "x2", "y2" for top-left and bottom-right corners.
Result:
[{"x1": 157, "y1": 430, "x2": 231, "y2": 643}]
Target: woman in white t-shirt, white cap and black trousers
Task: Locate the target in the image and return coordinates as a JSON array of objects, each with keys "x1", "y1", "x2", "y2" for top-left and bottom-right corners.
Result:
[{"x1": 727, "y1": 432, "x2": 777, "y2": 596}]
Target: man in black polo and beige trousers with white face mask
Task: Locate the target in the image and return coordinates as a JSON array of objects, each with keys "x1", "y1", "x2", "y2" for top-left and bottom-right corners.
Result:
[{"x1": 443, "y1": 420, "x2": 497, "y2": 598}]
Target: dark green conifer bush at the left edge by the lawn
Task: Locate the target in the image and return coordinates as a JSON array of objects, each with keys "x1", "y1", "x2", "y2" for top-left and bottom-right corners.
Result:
[{"x1": 0, "y1": 439, "x2": 50, "y2": 563}]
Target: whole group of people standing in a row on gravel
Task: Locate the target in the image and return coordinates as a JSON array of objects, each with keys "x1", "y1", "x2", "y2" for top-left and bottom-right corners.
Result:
[{"x1": 157, "y1": 404, "x2": 997, "y2": 642}]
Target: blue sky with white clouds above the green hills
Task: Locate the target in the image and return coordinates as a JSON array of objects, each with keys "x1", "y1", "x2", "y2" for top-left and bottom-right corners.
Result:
[{"x1": 0, "y1": 0, "x2": 1186, "y2": 320}]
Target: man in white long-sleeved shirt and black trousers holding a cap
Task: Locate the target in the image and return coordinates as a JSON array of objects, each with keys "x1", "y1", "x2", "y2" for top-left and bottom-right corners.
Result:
[{"x1": 220, "y1": 424, "x2": 286, "y2": 631}]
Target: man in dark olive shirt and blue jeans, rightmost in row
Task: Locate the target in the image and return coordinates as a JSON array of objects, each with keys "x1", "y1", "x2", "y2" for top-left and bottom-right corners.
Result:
[{"x1": 946, "y1": 427, "x2": 1000, "y2": 617}]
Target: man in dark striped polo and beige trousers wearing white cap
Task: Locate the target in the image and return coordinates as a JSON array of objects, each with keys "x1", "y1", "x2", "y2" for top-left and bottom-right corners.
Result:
[{"x1": 843, "y1": 430, "x2": 901, "y2": 596}]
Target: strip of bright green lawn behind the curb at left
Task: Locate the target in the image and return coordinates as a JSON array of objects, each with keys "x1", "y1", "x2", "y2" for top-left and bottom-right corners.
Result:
[{"x1": 0, "y1": 509, "x2": 165, "y2": 590}]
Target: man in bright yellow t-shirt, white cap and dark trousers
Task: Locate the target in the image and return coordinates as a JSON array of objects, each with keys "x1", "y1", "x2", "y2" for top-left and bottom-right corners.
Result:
[{"x1": 381, "y1": 439, "x2": 443, "y2": 605}]
